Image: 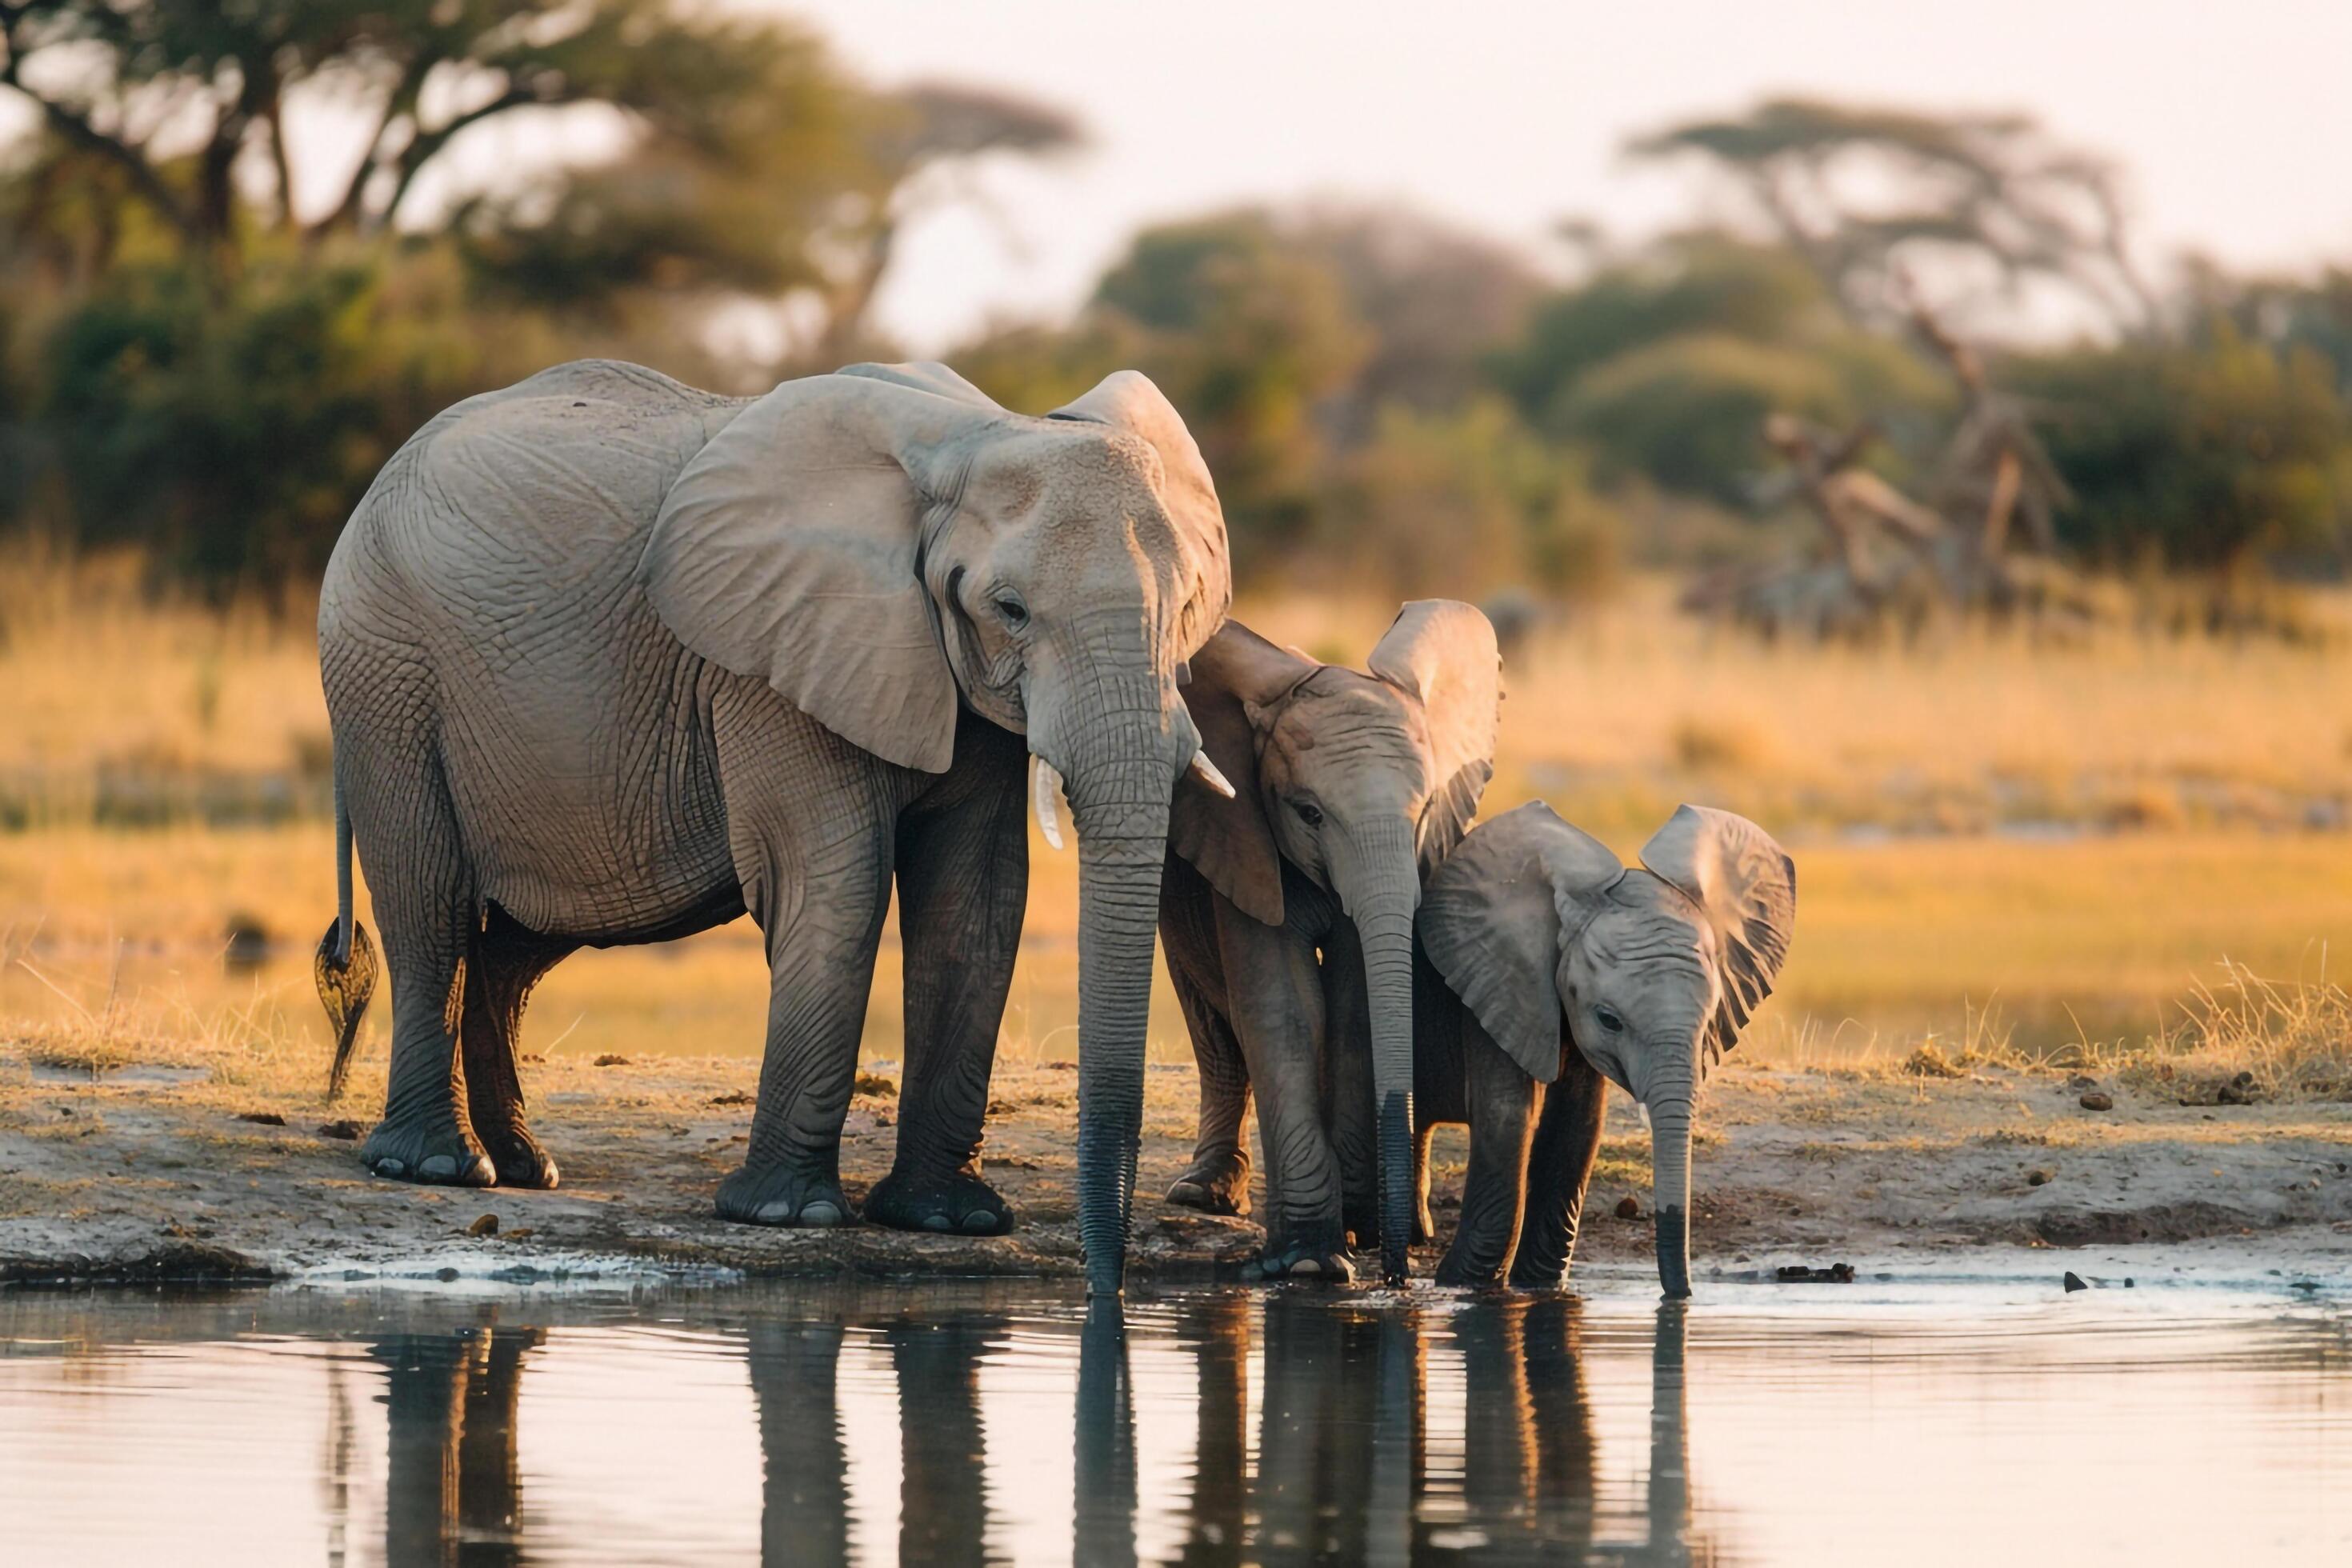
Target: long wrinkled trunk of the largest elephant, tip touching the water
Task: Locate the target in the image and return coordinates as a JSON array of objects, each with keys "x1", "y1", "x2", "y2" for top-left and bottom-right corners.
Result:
[{"x1": 1068, "y1": 731, "x2": 1176, "y2": 1295}]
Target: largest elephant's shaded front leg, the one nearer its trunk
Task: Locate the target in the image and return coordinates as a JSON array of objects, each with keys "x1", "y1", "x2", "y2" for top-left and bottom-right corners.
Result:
[{"x1": 866, "y1": 714, "x2": 1028, "y2": 1237}]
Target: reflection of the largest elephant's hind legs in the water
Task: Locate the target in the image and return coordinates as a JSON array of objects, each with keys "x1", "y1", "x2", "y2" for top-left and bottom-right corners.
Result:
[{"x1": 354, "y1": 1328, "x2": 546, "y2": 1568}]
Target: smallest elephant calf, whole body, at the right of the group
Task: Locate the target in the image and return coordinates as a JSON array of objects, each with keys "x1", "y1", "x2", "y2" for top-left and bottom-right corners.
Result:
[{"x1": 1416, "y1": 802, "x2": 1797, "y2": 1298}]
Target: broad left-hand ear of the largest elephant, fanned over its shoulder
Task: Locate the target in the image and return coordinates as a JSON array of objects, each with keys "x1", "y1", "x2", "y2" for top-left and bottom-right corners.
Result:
[{"x1": 638, "y1": 366, "x2": 1004, "y2": 774}]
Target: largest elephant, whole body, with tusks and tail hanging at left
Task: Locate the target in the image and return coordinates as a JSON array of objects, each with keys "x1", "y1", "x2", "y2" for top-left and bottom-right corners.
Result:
[{"x1": 320, "y1": 362, "x2": 1230, "y2": 1290}]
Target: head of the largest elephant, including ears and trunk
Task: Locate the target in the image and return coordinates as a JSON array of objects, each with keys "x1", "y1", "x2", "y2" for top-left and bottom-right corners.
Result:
[{"x1": 644, "y1": 364, "x2": 1233, "y2": 1290}]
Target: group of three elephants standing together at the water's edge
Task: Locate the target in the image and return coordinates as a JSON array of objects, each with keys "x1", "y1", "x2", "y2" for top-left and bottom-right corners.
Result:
[{"x1": 318, "y1": 360, "x2": 1794, "y2": 1295}]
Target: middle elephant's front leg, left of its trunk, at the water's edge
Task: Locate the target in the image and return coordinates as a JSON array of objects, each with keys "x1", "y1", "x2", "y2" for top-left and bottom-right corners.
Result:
[{"x1": 1218, "y1": 898, "x2": 1354, "y2": 1279}]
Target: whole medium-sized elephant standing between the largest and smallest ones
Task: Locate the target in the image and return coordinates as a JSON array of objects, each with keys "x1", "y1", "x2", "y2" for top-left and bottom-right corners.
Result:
[{"x1": 1159, "y1": 599, "x2": 1501, "y2": 1279}]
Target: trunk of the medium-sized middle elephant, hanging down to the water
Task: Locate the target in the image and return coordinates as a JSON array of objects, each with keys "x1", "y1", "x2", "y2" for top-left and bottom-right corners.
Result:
[{"x1": 1334, "y1": 822, "x2": 1421, "y2": 1286}]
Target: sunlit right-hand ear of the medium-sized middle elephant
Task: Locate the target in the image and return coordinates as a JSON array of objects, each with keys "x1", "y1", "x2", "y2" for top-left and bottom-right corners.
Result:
[{"x1": 1369, "y1": 599, "x2": 1503, "y2": 872}]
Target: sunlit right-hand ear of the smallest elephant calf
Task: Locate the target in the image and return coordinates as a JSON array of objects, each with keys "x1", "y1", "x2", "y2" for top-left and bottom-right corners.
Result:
[{"x1": 1642, "y1": 806, "x2": 1797, "y2": 1062}]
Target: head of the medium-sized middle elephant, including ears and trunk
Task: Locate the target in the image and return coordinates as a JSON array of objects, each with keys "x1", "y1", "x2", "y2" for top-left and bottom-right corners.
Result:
[{"x1": 1169, "y1": 599, "x2": 1503, "y2": 1281}]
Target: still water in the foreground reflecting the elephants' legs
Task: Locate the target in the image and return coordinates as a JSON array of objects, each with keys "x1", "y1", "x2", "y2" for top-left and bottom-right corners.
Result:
[{"x1": 0, "y1": 1277, "x2": 2352, "y2": 1566}]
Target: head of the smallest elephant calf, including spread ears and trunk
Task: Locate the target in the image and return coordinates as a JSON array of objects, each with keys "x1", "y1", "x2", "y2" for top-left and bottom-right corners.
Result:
[{"x1": 1421, "y1": 802, "x2": 1797, "y2": 1295}]
